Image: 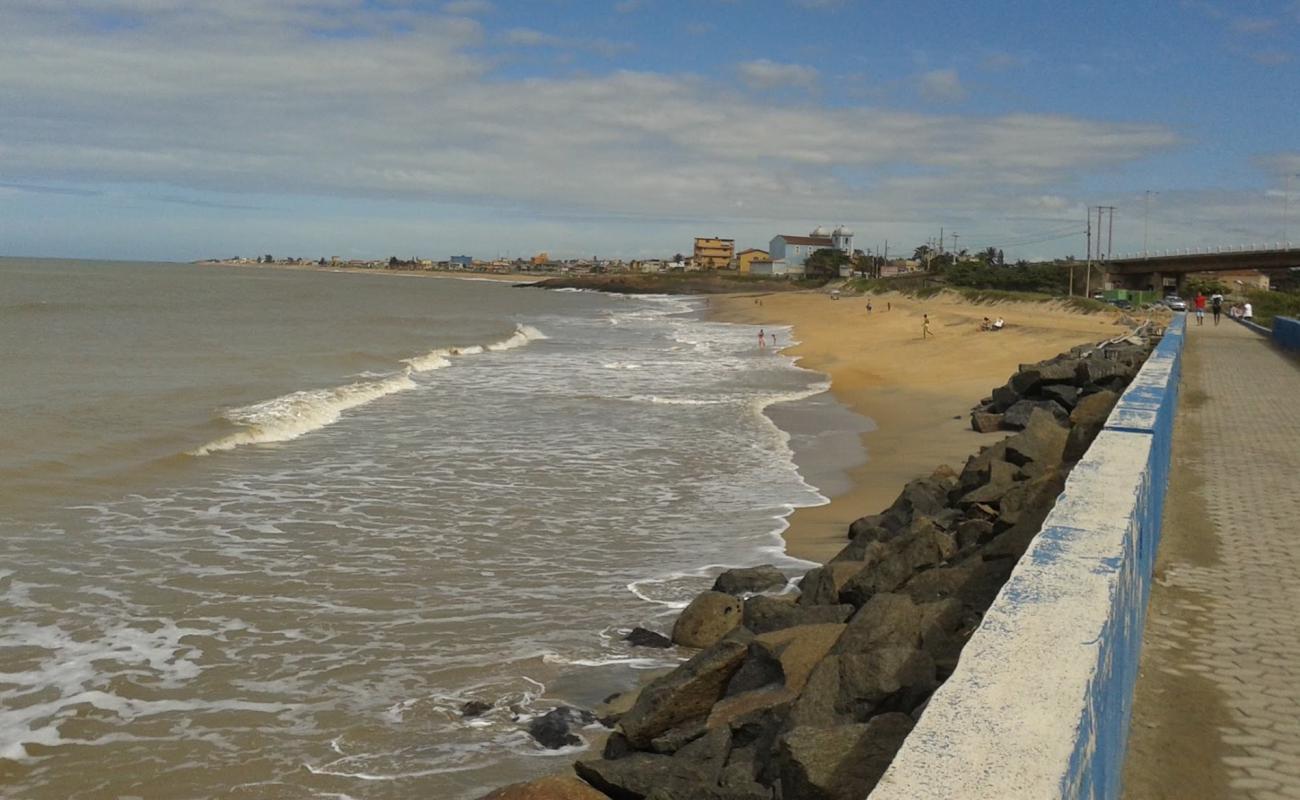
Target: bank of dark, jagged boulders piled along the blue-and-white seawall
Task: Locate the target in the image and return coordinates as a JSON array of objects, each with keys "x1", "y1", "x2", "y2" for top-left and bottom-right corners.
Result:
[{"x1": 483, "y1": 341, "x2": 1149, "y2": 800}]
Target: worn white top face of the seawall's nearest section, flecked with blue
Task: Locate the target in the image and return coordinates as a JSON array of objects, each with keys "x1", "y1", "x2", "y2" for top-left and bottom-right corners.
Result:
[{"x1": 871, "y1": 431, "x2": 1152, "y2": 800}]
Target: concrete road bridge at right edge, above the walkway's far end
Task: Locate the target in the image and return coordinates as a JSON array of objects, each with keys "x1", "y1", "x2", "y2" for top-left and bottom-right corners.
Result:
[{"x1": 1104, "y1": 242, "x2": 1300, "y2": 291}]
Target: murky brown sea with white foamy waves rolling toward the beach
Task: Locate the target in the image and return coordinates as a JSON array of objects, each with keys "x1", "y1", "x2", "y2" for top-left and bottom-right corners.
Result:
[{"x1": 0, "y1": 259, "x2": 868, "y2": 800}]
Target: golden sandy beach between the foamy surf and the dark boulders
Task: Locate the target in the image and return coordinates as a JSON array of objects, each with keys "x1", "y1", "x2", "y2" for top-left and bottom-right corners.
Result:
[{"x1": 710, "y1": 291, "x2": 1149, "y2": 562}]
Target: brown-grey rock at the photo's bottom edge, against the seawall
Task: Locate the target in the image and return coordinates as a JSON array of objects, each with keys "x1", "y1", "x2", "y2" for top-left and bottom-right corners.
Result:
[{"x1": 776, "y1": 714, "x2": 913, "y2": 800}]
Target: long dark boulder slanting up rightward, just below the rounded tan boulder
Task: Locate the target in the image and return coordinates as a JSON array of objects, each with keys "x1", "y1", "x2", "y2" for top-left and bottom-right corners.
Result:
[{"x1": 619, "y1": 639, "x2": 749, "y2": 749}]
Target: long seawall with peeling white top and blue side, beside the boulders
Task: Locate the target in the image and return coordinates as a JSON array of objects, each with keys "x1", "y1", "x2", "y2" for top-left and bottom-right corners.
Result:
[{"x1": 870, "y1": 315, "x2": 1187, "y2": 800}]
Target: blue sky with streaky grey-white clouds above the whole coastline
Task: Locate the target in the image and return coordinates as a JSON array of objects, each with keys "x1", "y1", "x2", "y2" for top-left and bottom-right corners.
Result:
[{"x1": 0, "y1": 0, "x2": 1300, "y2": 260}]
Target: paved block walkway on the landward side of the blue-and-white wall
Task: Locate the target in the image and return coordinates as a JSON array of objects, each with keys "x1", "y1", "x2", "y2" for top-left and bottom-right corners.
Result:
[{"x1": 1125, "y1": 319, "x2": 1300, "y2": 800}]
